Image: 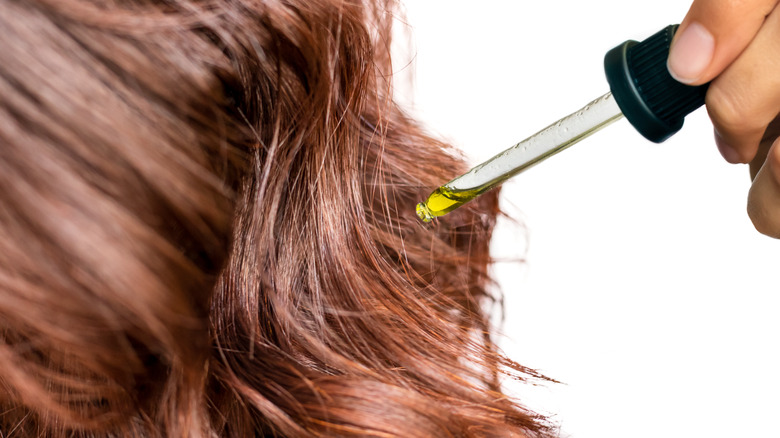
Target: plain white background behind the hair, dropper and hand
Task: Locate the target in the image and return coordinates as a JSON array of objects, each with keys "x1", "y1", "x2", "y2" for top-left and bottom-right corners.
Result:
[{"x1": 395, "y1": 0, "x2": 780, "y2": 438}]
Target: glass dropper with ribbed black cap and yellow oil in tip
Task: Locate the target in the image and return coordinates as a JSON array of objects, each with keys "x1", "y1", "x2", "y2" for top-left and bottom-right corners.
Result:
[{"x1": 417, "y1": 25, "x2": 707, "y2": 222}]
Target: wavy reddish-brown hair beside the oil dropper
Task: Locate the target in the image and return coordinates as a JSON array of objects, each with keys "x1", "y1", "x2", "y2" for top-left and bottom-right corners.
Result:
[{"x1": 0, "y1": 0, "x2": 551, "y2": 437}]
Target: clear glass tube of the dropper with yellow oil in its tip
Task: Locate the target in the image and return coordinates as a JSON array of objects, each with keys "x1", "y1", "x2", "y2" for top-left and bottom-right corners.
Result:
[{"x1": 417, "y1": 93, "x2": 623, "y2": 222}]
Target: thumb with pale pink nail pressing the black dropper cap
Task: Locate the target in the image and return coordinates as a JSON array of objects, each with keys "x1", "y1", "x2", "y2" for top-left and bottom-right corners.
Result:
[{"x1": 668, "y1": 0, "x2": 777, "y2": 85}]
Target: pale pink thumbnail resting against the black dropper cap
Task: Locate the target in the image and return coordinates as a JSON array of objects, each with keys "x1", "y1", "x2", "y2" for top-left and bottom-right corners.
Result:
[{"x1": 667, "y1": 21, "x2": 715, "y2": 84}]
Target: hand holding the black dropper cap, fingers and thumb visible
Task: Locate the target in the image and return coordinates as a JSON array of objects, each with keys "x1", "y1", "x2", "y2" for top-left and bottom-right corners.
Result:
[{"x1": 669, "y1": 0, "x2": 780, "y2": 238}]
